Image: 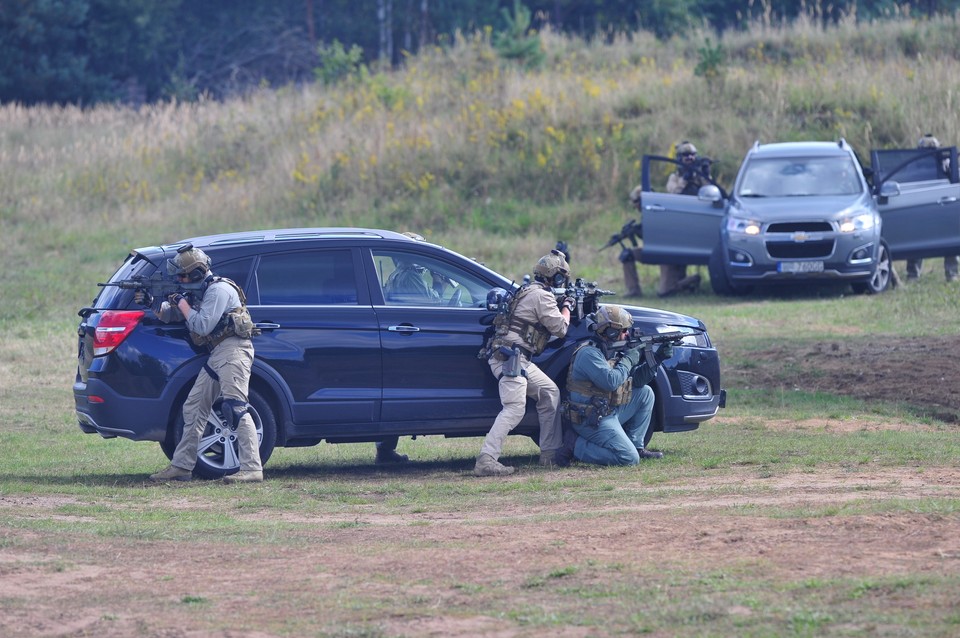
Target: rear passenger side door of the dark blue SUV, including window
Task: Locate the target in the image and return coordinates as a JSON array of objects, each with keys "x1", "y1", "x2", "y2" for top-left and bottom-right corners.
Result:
[{"x1": 247, "y1": 242, "x2": 382, "y2": 438}]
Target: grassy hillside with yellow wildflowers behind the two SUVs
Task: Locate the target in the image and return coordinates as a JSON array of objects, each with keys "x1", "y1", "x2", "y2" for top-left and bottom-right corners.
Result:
[{"x1": 0, "y1": 19, "x2": 960, "y2": 323}]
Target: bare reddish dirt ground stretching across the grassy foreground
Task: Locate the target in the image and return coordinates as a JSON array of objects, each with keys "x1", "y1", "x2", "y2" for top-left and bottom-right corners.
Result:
[{"x1": 0, "y1": 467, "x2": 960, "y2": 638}]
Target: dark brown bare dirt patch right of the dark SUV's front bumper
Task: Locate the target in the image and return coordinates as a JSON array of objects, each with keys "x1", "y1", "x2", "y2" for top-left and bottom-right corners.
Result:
[{"x1": 723, "y1": 336, "x2": 960, "y2": 423}]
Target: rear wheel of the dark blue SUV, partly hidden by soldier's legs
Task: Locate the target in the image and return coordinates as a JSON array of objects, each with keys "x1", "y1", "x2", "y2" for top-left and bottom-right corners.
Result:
[{"x1": 160, "y1": 390, "x2": 277, "y2": 479}]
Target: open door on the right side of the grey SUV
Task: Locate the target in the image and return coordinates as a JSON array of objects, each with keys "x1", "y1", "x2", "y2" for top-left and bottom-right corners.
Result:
[{"x1": 870, "y1": 146, "x2": 960, "y2": 259}]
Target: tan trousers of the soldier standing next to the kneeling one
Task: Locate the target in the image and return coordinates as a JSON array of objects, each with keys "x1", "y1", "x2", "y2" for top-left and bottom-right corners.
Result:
[{"x1": 480, "y1": 357, "x2": 563, "y2": 459}]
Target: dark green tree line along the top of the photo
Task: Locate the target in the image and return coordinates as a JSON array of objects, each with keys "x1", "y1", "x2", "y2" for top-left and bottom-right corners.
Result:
[{"x1": 0, "y1": 0, "x2": 960, "y2": 106}]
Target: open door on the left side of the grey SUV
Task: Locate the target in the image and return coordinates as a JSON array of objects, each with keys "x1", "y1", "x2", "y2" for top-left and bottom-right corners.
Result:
[{"x1": 640, "y1": 155, "x2": 726, "y2": 264}]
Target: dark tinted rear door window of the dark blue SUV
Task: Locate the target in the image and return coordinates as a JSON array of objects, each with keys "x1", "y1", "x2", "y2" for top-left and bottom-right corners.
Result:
[{"x1": 257, "y1": 250, "x2": 357, "y2": 306}]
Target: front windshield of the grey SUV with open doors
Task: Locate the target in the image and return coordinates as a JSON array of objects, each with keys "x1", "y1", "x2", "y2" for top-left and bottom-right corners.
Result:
[{"x1": 737, "y1": 157, "x2": 863, "y2": 197}]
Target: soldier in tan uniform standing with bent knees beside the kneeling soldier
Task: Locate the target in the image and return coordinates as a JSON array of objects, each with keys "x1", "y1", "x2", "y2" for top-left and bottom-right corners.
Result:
[{"x1": 473, "y1": 250, "x2": 575, "y2": 476}]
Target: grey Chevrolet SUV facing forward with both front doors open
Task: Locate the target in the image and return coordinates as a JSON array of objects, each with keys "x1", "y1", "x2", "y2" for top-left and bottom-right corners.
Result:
[{"x1": 641, "y1": 139, "x2": 960, "y2": 295}]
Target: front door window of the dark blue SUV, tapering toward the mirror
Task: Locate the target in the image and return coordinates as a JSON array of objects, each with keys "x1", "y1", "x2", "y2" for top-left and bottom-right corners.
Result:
[{"x1": 373, "y1": 250, "x2": 490, "y2": 306}]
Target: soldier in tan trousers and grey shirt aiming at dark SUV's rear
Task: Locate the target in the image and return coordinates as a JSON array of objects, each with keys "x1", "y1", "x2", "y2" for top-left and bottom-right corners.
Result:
[{"x1": 142, "y1": 246, "x2": 263, "y2": 483}]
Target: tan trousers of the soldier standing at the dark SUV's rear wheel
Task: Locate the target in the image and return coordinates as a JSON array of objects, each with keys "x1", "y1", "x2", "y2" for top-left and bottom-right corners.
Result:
[{"x1": 171, "y1": 337, "x2": 263, "y2": 471}]
